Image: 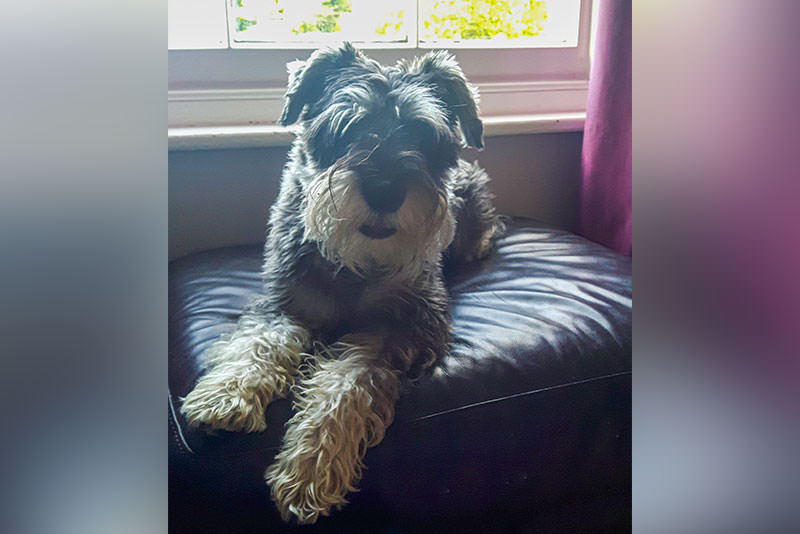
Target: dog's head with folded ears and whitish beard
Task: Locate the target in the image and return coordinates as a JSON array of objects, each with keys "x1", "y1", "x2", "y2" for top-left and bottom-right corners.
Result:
[{"x1": 280, "y1": 43, "x2": 483, "y2": 277}]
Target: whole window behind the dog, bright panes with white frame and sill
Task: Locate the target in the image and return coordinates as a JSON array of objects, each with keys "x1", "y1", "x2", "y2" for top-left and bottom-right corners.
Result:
[{"x1": 168, "y1": 0, "x2": 591, "y2": 146}]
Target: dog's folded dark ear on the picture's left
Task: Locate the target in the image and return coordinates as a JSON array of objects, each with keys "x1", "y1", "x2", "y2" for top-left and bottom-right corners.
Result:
[{"x1": 278, "y1": 43, "x2": 361, "y2": 126}]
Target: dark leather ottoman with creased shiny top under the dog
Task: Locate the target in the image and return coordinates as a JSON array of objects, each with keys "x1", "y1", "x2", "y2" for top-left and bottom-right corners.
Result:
[{"x1": 169, "y1": 219, "x2": 632, "y2": 532}]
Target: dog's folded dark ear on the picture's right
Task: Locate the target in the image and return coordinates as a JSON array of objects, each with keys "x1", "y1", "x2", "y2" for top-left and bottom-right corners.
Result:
[{"x1": 405, "y1": 50, "x2": 483, "y2": 148}]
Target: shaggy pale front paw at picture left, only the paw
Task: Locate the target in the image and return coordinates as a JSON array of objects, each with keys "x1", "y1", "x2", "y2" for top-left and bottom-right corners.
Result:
[{"x1": 181, "y1": 371, "x2": 268, "y2": 432}]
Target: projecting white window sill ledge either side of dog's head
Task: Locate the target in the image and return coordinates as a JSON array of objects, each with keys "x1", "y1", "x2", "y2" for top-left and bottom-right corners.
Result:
[{"x1": 168, "y1": 112, "x2": 586, "y2": 151}]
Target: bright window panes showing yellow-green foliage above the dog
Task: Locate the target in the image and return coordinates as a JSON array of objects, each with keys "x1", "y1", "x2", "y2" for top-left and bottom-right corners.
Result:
[{"x1": 169, "y1": 0, "x2": 581, "y2": 50}]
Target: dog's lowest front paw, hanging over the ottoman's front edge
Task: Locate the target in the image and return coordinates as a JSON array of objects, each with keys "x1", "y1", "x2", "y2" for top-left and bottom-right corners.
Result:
[{"x1": 264, "y1": 456, "x2": 347, "y2": 525}]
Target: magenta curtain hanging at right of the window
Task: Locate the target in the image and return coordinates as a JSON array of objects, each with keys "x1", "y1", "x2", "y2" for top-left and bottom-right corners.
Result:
[{"x1": 578, "y1": 0, "x2": 632, "y2": 255}]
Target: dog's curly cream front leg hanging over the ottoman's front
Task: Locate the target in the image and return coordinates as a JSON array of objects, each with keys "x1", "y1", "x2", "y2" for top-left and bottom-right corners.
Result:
[{"x1": 265, "y1": 336, "x2": 399, "y2": 523}]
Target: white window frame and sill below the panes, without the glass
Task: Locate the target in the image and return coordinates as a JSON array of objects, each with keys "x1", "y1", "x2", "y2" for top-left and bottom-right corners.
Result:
[{"x1": 168, "y1": 0, "x2": 597, "y2": 150}]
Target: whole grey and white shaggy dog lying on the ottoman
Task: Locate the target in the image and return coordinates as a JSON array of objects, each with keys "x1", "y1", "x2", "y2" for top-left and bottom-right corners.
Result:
[{"x1": 181, "y1": 44, "x2": 503, "y2": 523}]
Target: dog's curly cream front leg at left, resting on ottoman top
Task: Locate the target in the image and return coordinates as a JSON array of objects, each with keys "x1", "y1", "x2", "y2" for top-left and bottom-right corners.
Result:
[{"x1": 181, "y1": 314, "x2": 310, "y2": 432}]
